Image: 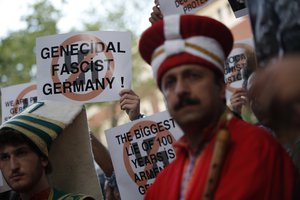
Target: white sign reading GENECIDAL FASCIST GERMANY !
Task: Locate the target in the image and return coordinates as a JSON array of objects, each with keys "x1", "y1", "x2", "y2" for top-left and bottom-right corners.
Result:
[{"x1": 36, "y1": 31, "x2": 131, "y2": 103}]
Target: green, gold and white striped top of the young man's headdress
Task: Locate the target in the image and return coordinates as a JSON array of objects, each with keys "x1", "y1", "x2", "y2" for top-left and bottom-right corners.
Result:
[{"x1": 0, "y1": 101, "x2": 83, "y2": 157}]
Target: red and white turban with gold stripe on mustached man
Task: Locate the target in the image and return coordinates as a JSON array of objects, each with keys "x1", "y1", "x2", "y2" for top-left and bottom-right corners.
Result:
[{"x1": 139, "y1": 15, "x2": 233, "y2": 86}]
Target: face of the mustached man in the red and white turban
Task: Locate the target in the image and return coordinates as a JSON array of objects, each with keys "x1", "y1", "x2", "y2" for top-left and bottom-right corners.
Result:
[{"x1": 161, "y1": 64, "x2": 225, "y2": 129}]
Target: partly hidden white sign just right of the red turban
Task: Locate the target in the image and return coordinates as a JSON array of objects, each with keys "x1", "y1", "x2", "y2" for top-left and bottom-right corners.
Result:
[{"x1": 225, "y1": 38, "x2": 257, "y2": 100}]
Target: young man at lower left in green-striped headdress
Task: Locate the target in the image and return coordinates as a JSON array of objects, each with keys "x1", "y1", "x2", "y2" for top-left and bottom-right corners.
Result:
[{"x1": 0, "y1": 102, "x2": 94, "y2": 200}]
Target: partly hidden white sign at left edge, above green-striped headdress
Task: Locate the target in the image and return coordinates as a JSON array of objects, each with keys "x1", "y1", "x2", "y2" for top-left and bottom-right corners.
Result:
[{"x1": 1, "y1": 83, "x2": 38, "y2": 122}]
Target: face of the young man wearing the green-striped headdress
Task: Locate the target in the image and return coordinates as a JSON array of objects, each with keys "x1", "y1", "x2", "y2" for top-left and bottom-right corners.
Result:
[{"x1": 0, "y1": 144, "x2": 48, "y2": 192}]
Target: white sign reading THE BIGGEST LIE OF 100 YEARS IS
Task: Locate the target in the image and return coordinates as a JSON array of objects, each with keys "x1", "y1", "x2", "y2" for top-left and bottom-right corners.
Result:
[{"x1": 105, "y1": 111, "x2": 182, "y2": 200}]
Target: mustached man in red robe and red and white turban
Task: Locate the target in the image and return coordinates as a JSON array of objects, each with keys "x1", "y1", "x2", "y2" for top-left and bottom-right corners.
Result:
[{"x1": 139, "y1": 15, "x2": 299, "y2": 200}]
